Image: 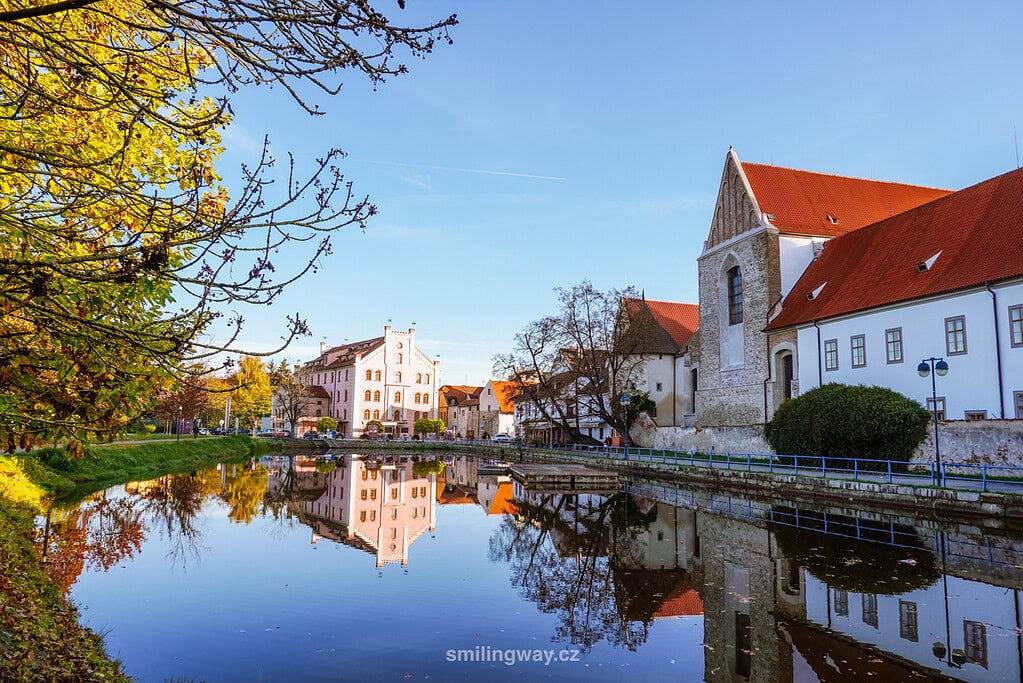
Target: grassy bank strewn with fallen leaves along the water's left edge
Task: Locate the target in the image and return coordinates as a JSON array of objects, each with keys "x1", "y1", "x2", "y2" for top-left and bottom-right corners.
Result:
[{"x1": 0, "y1": 437, "x2": 279, "y2": 681}]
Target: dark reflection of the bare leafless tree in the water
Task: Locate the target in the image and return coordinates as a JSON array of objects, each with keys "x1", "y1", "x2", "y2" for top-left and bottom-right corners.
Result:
[{"x1": 489, "y1": 493, "x2": 671, "y2": 651}]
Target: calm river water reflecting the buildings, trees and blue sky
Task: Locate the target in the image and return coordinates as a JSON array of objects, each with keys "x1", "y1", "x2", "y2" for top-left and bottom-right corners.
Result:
[{"x1": 39, "y1": 454, "x2": 1023, "y2": 683}]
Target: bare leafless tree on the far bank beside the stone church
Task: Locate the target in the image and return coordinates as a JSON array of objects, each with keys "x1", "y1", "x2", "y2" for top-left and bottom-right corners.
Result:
[{"x1": 493, "y1": 280, "x2": 657, "y2": 445}]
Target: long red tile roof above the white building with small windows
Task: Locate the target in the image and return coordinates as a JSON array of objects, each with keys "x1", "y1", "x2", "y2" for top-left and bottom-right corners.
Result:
[{"x1": 767, "y1": 162, "x2": 1023, "y2": 329}]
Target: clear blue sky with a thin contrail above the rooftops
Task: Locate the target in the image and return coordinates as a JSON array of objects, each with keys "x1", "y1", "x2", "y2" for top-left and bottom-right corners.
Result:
[{"x1": 205, "y1": 0, "x2": 1023, "y2": 383}]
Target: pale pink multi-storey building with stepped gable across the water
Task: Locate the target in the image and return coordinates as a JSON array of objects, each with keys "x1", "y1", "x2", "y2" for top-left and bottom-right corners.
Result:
[{"x1": 284, "y1": 325, "x2": 440, "y2": 438}]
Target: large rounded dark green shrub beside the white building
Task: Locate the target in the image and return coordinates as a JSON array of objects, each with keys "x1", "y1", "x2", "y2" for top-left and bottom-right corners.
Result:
[{"x1": 764, "y1": 383, "x2": 931, "y2": 468}]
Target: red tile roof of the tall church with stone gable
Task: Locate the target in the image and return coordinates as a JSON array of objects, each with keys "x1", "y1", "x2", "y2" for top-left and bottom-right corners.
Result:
[{"x1": 743, "y1": 162, "x2": 949, "y2": 237}]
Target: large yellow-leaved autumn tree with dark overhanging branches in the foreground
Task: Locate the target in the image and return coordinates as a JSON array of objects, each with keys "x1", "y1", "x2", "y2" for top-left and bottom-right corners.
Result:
[{"x1": 0, "y1": 0, "x2": 455, "y2": 450}]
